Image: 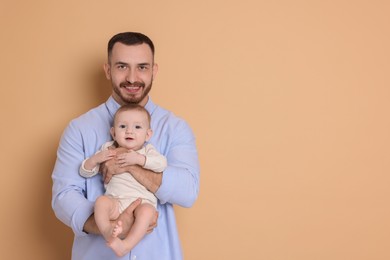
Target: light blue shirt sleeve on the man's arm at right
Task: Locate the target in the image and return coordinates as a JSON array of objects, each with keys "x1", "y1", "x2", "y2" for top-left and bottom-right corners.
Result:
[{"x1": 155, "y1": 120, "x2": 200, "y2": 207}]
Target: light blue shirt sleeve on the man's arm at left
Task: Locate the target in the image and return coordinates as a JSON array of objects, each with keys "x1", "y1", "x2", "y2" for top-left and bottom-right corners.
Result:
[{"x1": 52, "y1": 122, "x2": 94, "y2": 236}]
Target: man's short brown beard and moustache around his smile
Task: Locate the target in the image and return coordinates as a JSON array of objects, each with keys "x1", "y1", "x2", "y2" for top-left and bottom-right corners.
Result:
[{"x1": 114, "y1": 79, "x2": 153, "y2": 104}]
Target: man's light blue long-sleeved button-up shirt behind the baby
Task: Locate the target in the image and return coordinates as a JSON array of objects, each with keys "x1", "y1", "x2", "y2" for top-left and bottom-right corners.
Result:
[{"x1": 52, "y1": 97, "x2": 199, "y2": 260}]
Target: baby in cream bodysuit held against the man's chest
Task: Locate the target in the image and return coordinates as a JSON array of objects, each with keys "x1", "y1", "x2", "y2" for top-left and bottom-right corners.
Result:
[{"x1": 80, "y1": 104, "x2": 167, "y2": 256}]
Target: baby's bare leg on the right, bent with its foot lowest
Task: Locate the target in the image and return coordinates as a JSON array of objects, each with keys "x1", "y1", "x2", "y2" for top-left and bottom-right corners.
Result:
[{"x1": 108, "y1": 203, "x2": 156, "y2": 256}]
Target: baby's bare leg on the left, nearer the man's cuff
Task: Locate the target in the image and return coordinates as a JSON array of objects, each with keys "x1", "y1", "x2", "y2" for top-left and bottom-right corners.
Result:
[{"x1": 95, "y1": 196, "x2": 119, "y2": 242}]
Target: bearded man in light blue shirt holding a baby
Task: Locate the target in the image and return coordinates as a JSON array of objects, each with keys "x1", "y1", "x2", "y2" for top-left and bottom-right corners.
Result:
[{"x1": 52, "y1": 32, "x2": 199, "y2": 260}]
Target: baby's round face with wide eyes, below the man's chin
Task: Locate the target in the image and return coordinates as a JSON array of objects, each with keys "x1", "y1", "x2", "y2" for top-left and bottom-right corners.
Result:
[{"x1": 113, "y1": 110, "x2": 151, "y2": 150}]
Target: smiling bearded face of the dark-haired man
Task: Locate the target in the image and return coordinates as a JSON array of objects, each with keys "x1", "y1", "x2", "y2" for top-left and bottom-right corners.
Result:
[{"x1": 104, "y1": 43, "x2": 158, "y2": 106}]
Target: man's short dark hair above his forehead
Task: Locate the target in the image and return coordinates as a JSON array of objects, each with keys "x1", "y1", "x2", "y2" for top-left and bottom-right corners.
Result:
[{"x1": 107, "y1": 32, "x2": 154, "y2": 59}]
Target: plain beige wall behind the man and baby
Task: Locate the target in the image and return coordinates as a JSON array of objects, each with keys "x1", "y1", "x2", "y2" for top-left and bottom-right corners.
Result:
[{"x1": 0, "y1": 0, "x2": 390, "y2": 260}]
